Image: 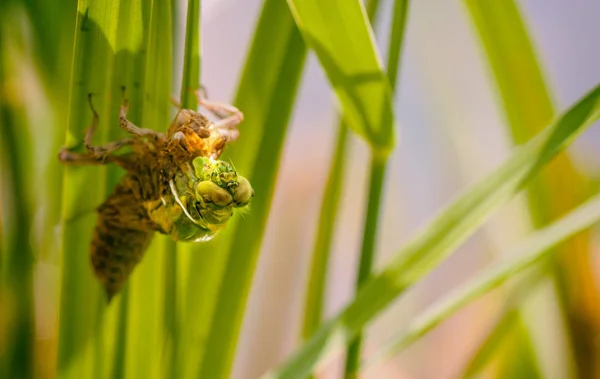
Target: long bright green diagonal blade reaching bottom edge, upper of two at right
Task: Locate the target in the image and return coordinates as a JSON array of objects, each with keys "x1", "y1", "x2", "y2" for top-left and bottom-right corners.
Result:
[{"x1": 265, "y1": 86, "x2": 600, "y2": 379}]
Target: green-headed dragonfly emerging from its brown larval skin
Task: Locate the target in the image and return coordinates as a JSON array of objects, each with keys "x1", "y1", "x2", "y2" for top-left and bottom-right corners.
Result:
[{"x1": 59, "y1": 89, "x2": 254, "y2": 301}]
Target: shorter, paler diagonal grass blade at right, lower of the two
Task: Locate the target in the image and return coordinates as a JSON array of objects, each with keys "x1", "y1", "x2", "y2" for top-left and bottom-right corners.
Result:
[{"x1": 367, "y1": 196, "x2": 600, "y2": 366}]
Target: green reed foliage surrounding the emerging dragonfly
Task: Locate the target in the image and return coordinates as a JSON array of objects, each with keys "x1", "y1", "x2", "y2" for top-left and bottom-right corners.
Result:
[{"x1": 0, "y1": 0, "x2": 600, "y2": 379}]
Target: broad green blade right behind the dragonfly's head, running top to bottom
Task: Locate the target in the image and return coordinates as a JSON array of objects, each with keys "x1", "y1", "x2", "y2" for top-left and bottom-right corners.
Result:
[{"x1": 196, "y1": 0, "x2": 306, "y2": 379}]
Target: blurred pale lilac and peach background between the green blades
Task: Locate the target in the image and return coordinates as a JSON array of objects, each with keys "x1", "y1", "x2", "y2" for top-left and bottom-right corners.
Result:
[{"x1": 0, "y1": 0, "x2": 600, "y2": 379}]
